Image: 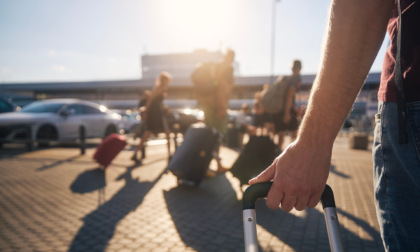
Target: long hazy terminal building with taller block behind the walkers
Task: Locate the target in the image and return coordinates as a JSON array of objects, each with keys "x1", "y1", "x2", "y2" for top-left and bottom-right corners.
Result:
[{"x1": 0, "y1": 50, "x2": 380, "y2": 109}]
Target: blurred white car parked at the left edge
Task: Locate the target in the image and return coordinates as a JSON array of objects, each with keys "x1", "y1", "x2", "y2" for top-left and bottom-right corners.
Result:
[{"x1": 0, "y1": 99, "x2": 121, "y2": 148}]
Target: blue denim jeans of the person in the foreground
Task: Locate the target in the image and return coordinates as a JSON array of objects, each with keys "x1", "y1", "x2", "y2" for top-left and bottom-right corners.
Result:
[{"x1": 372, "y1": 102, "x2": 420, "y2": 251}]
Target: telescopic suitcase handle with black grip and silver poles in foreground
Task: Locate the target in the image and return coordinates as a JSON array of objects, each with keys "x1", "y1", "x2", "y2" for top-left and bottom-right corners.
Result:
[{"x1": 242, "y1": 182, "x2": 344, "y2": 252}]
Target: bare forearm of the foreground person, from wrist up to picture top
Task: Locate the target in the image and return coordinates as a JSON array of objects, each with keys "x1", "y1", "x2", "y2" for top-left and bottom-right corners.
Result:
[{"x1": 299, "y1": 0, "x2": 394, "y2": 146}]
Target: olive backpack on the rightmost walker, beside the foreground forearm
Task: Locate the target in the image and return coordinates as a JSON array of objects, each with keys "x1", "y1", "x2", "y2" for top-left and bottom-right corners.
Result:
[{"x1": 261, "y1": 75, "x2": 300, "y2": 113}]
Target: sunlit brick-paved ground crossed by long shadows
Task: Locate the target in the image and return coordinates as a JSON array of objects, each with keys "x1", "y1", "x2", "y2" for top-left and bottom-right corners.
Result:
[{"x1": 0, "y1": 133, "x2": 383, "y2": 252}]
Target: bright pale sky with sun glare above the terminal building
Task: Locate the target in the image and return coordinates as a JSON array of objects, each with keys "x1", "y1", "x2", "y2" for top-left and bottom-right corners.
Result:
[{"x1": 0, "y1": 0, "x2": 387, "y2": 83}]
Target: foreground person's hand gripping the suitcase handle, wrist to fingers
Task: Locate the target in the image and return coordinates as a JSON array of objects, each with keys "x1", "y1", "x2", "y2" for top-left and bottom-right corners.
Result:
[{"x1": 249, "y1": 139, "x2": 331, "y2": 212}]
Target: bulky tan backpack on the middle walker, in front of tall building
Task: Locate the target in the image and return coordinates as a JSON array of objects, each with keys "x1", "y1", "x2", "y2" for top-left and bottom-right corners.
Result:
[{"x1": 191, "y1": 61, "x2": 217, "y2": 96}]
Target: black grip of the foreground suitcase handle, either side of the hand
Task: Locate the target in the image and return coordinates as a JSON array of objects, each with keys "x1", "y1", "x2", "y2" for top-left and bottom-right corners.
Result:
[{"x1": 243, "y1": 181, "x2": 335, "y2": 210}]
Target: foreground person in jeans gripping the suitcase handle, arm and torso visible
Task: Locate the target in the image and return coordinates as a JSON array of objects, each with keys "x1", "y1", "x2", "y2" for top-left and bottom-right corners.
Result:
[{"x1": 250, "y1": 0, "x2": 420, "y2": 251}]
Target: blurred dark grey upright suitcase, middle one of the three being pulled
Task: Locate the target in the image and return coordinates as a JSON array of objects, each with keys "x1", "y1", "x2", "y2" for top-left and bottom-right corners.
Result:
[{"x1": 168, "y1": 123, "x2": 220, "y2": 186}]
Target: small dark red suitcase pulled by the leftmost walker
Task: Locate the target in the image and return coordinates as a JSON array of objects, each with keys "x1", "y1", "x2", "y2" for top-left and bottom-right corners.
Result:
[{"x1": 93, "y1": 133, "x2": 127, "y2": 168}]
